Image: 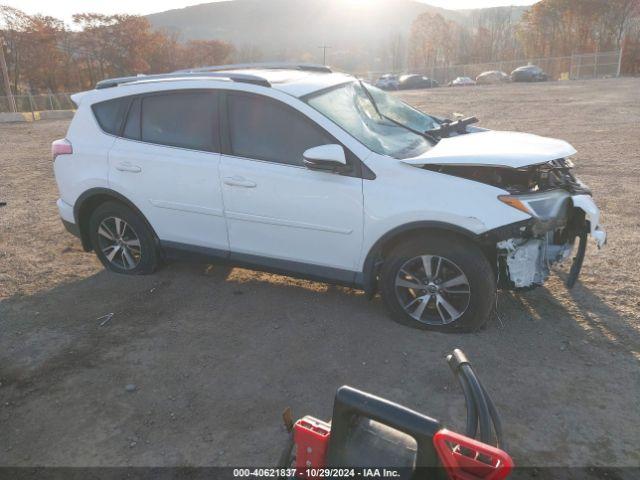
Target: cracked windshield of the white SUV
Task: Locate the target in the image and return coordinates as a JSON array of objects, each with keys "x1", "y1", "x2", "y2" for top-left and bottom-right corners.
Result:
[{"x1": 307, "y1": 82, "x2": 438, "y2": 159}]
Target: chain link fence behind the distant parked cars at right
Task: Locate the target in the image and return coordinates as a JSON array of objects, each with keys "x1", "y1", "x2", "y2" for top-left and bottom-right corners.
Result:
[{"x1": 356, "y1": 51, "x2": 620, "y2": 85}]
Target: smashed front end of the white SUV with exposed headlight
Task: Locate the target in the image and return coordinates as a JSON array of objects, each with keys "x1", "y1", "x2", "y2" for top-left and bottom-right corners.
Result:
[{"x1": 423, "y1": 159, "x2": 606, "y2": 289}]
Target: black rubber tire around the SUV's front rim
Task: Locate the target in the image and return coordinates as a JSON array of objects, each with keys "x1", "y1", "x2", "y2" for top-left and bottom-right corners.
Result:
[{"x1": 380, "y1": 234, "x2": 496, "y2": 332}]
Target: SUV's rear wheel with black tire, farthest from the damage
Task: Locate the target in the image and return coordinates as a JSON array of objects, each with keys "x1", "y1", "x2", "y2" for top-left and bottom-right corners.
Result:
[{"x1": 89, "y1": 202, "x2": 159, "y2": 275}]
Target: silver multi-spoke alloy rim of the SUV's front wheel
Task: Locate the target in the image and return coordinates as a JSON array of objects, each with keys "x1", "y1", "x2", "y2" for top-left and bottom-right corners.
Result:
[{"x1": 395, "y1": 255, "x2": 471, "y2": 325}]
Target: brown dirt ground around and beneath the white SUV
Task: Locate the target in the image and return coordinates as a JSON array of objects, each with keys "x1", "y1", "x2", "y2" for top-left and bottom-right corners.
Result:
[{"x1": 0, "y1": 79, "x2": 640, "y2": 467}]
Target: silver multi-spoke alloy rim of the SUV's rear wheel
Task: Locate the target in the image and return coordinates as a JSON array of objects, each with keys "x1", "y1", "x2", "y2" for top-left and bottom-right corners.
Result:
[{"x1": 98, "y1": 217, "x2": 142, "y2": 270}]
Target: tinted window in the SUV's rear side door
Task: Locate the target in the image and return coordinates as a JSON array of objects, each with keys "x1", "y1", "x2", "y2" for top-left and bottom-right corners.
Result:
[{"x1": 141, "y1": 92, "x2": 218, "y2": 151}]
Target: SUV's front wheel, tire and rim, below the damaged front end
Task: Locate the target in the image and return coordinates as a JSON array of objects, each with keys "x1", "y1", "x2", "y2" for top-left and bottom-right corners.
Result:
[{"x1": 380, "y1": 235, "x2": 496, "y2": 331}]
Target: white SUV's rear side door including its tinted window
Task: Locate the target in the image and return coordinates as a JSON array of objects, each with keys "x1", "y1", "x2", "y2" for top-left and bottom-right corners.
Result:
[{"x1": 109, "y1": 90, "x2": 229, "y2": 252}]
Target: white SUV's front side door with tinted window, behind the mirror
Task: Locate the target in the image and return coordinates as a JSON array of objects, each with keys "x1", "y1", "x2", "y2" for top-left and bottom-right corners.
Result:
[{"x1": 220, "y1": 92, "x2": 363, "y2": 281}]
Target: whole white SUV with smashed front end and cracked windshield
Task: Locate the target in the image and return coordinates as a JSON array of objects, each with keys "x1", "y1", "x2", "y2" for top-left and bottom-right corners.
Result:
[{"x1": 52, "y1": 64, "x2": 606, "y2": 331}]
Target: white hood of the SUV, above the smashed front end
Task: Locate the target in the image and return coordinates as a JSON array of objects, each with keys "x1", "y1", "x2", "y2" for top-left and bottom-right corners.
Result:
[{"x1": 401, "y1": 130, "x2": 576, "y2": 168}]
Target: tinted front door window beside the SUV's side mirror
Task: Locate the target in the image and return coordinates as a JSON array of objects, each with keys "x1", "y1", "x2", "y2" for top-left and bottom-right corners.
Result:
[{"x1": 228, "y1": 94, "x2": 336, "y2": 165}]
